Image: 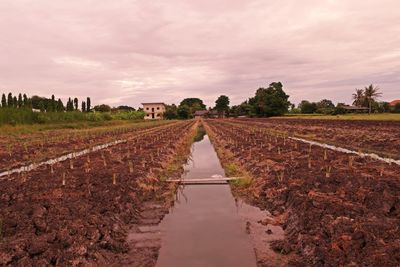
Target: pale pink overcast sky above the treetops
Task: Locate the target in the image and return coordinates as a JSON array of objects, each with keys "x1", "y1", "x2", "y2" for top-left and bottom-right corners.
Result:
[{"x1": 0, "y1": 0, "x2": 400, "y2": 107}]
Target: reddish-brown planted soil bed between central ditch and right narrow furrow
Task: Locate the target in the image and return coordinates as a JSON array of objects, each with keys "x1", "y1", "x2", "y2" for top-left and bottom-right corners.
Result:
[{"x1": 206, "y1": 120, "x2": 400, "y2": 266}]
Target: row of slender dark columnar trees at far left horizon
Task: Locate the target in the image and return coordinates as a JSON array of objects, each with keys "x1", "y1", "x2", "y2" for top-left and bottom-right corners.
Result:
[{"x1": 1, "y1": 93, "x2": 91, "y2": 112}]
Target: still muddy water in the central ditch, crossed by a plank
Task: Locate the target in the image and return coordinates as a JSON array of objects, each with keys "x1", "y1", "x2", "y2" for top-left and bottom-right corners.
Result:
[{"x1": 157, "y1": 136, "x2": 256, "y2": 267}]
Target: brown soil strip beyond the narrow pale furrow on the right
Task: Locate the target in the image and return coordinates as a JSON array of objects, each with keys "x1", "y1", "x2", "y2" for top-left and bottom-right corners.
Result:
[{"x1": 233, "y1": 118, "x2": 400, "y2": 159}]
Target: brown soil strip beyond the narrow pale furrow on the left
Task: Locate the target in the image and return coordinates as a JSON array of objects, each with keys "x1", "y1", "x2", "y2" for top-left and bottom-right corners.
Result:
[{"x1": 0, "y1": 123, "x2": 171, "y2": 172}]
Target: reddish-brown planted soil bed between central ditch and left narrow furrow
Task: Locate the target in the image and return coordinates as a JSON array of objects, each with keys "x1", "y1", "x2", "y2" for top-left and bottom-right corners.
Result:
[{"x1": 0, "y1": 121, "x2": 194, "y2": 266}]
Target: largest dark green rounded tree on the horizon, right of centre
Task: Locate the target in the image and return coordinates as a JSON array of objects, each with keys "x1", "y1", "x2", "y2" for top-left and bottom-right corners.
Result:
[{"x1": 248, "y1": 82, "x2": 289, "y2": 117}]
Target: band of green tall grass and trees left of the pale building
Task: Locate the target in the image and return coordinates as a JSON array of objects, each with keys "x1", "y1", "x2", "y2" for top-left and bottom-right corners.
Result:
[{"x1": 0, "y1": 93, "x2": 144, "y2": 125}]
